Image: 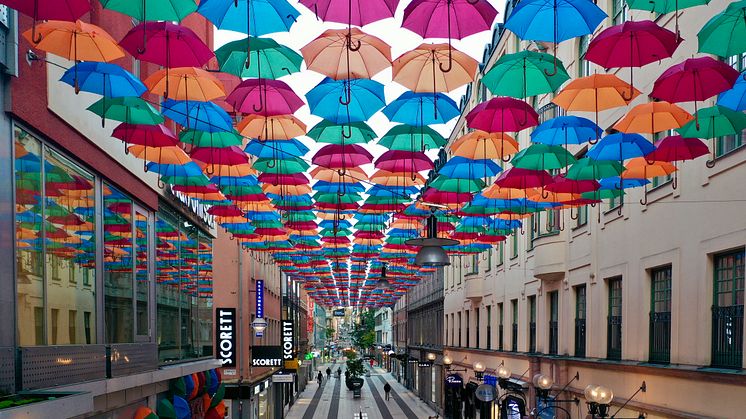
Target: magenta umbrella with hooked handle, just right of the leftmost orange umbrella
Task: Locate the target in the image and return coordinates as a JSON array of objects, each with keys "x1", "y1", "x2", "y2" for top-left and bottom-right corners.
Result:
[{"x1": 119, "y1": 22, "x2": 215, "y2": 98}]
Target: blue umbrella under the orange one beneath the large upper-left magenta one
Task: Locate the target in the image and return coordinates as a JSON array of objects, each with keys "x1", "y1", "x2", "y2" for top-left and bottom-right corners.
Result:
[{"x1": 161, "y1": 99, "x2": 233, "y2": 132}]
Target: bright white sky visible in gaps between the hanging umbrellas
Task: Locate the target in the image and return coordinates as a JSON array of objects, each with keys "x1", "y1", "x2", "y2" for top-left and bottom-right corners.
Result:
[{"x1": 215, "y1": 0, "x2": 505, "y2": 167}]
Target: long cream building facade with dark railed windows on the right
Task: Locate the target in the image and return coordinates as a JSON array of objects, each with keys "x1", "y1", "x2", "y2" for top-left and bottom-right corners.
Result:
[{"x1": 442, "y1": 0, "x2": 746, "y2": 417}]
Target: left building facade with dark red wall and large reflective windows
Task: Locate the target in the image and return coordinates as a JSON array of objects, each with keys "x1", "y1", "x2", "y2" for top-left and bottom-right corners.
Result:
[{"x1": 0, "y1": 2, "x2": 219, "y2": 417}]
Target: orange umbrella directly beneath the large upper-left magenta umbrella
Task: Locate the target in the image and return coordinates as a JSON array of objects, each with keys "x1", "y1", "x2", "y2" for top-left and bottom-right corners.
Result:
[{"x1": 144, "y1": 67, "x2": 225, "y2": 102}]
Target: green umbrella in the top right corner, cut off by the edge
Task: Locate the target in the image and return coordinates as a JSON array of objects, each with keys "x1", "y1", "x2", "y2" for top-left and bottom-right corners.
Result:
[{"x1": 697, "y1": 0, "x2": 746, "y2": 57}]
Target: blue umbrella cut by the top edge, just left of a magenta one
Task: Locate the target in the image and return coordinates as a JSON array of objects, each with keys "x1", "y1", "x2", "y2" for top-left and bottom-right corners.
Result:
[{"x1": 197, "y1": 0, "x2": 300, "y2": 36}]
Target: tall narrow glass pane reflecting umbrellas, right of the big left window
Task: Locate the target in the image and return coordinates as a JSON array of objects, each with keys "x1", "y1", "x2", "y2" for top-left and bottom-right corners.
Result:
[{"x1": 103, "y1": 184, "x2": 135, "y2": 343}]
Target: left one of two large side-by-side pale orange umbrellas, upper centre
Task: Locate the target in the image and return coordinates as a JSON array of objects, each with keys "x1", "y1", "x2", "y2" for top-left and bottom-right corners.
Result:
[{"x1": 300, "y1": 28, "x2": 391, "y2": 80}]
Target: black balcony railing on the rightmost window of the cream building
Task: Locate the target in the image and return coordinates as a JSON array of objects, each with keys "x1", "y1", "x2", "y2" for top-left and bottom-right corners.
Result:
[{"x1": 712, "y1": 305, "x2": 743, "y2": 368}]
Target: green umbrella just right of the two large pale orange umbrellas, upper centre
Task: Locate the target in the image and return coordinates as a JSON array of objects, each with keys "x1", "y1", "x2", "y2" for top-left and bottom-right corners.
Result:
[{"x1": 482, "y1": 51, "x2": 570, "y2": 99}]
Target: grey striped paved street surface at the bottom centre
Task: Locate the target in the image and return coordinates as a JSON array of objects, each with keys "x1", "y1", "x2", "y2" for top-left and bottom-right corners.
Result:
[{"x1": 286, "y1": 363, "x2": 436, "y2": 419}]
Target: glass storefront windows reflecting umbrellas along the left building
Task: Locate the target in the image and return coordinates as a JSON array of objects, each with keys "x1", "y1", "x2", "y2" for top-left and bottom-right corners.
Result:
[{"x1": 14, "y1": 126, "x2": 213, "y2": 362}]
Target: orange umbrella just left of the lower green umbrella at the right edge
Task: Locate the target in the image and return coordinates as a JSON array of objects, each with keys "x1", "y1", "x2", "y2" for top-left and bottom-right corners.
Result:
[{"x1": 614, "y1": 102, "x2": 694, "y2": 134}]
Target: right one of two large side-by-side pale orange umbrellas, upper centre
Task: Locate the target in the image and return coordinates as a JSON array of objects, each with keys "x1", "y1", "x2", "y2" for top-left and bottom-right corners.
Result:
[{"x1": 393, "y1": 44, "x2": 478, "y2": 93}]
